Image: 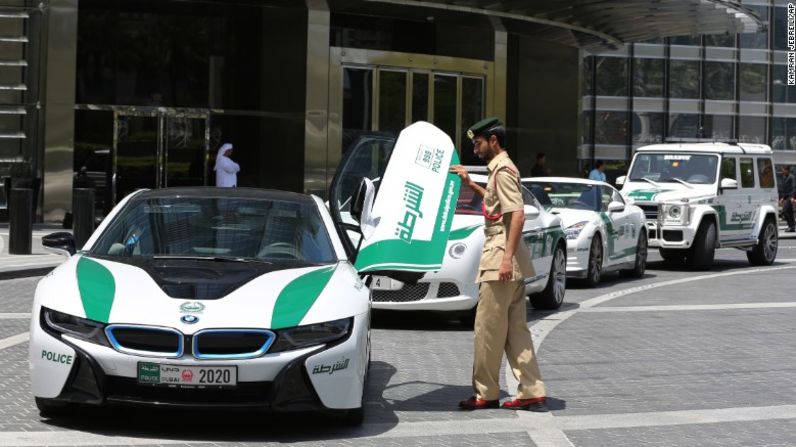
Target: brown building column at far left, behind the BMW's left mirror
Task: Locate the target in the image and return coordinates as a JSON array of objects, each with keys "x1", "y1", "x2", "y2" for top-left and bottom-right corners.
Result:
[{"x1": 39, "y1": 0, "x2": 78, "y2": 222}]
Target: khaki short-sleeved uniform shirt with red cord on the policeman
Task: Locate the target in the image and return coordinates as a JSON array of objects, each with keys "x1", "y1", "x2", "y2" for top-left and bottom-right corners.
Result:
[{"x1": 476, "y1": 152, "x2": 536, "y2": 282}]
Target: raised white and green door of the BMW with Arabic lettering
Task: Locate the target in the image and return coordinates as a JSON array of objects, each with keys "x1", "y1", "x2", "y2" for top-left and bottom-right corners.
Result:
[{"x1": 329, "y1": 121, "x2": 460, "y2": 282}]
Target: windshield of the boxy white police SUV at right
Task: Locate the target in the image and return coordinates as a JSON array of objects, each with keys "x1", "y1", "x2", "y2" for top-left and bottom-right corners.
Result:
[{"x1": 630, "y1": 154, "x2": 719, "y2": 185}]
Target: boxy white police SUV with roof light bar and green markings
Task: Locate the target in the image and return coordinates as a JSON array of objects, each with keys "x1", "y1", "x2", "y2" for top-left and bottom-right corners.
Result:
[{"x1": 617, "y1": 142, "x2": 778, "y2": 270}]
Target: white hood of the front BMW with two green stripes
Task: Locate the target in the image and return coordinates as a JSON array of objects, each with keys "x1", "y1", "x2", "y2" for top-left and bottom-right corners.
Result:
[{"x1": 36, "y1": 255, "x2": 369, "y2": 333}]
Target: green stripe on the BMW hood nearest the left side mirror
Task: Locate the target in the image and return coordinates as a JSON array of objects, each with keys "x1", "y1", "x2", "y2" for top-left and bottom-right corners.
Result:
[{"x1": 76, "y1": 256, "x2": 116, "y2": 323}]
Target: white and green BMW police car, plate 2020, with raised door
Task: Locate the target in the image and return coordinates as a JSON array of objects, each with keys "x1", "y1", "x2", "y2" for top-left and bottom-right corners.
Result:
[{"x1": 29, "y1": 123, "x2": 459, "y2": 424}]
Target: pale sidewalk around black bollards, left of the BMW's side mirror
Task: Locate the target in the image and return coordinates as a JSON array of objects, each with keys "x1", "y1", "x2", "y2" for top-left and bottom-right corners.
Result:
[{"x1": 0, "y1": 224, "x2": 71, "y2": 279}]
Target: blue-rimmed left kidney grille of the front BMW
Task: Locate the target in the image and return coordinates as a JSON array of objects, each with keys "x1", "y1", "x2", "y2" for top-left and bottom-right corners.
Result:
[{"x1": 105, "y1": 324, "x2": 183, "y2": 357}]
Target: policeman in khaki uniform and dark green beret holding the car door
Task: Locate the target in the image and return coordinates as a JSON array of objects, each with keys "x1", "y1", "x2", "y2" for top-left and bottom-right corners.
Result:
[{"x1": 451, "y1": 118, "x2": 547, "y2": 411}]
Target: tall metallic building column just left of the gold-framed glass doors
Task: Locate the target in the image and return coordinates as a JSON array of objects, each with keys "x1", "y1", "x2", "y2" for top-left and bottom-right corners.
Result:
[{"x1": 304, "y1": 0, "x2": 336, "y2": 198}]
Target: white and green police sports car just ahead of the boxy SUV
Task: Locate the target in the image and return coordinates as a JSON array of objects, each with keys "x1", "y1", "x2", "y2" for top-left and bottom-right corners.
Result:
[{"x1": 522, "y1": 177, "x2": 647, "y2": 287}]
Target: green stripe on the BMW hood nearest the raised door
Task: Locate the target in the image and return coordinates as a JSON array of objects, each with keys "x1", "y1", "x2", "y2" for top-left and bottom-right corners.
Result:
[{"x1": 271, "y1": 265, "x2": 337, "y2": 329}]
